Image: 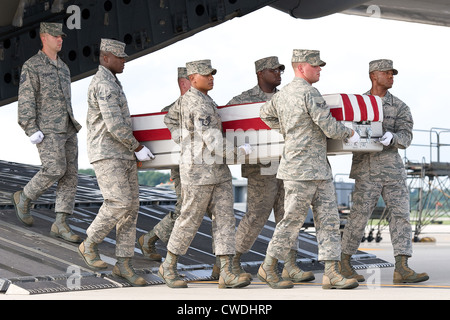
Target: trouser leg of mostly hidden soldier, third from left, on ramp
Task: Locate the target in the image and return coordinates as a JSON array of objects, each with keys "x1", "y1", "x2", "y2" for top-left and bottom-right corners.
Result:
[{"x1": 153, "y1": 167, "x2": 182, "y2": 243}]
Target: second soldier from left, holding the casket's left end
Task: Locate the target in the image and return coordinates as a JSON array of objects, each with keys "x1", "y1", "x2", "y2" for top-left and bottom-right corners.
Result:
[{"x1": 78, "y1": 39, "x2": 154, "y2": 286}]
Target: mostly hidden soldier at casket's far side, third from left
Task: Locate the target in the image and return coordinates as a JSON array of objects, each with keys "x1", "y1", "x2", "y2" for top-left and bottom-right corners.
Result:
[{"x1": 137, "y1": 67, "x2": 191, "y2": 261}]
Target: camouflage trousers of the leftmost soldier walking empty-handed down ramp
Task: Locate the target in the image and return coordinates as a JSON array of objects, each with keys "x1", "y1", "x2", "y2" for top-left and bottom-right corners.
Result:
[{"x1": 24, "y1": 126, "x2": 78, "y2": 214}]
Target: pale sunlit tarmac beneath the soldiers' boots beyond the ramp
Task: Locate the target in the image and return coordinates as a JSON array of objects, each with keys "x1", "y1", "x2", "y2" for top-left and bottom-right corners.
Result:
[{"x1": 0, "y1": 225, "x2": 450, "y2": 302}]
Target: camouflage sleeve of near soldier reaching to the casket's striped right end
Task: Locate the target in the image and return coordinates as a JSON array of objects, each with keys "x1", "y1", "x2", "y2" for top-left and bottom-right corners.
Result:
[{"x1": 306, "y1": 91, "x2": 352, "y2": 139}]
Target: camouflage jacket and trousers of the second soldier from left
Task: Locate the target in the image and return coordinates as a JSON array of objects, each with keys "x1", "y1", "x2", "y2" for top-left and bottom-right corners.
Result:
[{"x1": 86, "y1": 50, "x2": 140, "y2": 257}]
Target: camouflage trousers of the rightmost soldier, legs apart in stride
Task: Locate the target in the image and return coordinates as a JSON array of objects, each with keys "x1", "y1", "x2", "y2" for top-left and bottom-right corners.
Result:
[{"x1": 342, "y1": 179, "x2": 412, "y2": 256}]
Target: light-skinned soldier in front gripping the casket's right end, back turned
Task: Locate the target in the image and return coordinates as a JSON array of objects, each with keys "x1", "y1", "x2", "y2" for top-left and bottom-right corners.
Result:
[{"x1": 258, "y1": 49, "x2": 359, "y2": 289}]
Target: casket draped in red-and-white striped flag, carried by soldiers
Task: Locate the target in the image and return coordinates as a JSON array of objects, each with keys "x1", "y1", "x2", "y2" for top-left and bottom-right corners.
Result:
[{"x1": 132, "y1": 94, "x2": 383, "y2": 169}]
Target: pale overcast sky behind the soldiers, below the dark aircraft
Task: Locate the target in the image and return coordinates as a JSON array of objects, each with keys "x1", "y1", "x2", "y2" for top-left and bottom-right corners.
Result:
[{"x1": 0, "y1": 7, "x2": 450, "y2": 177}]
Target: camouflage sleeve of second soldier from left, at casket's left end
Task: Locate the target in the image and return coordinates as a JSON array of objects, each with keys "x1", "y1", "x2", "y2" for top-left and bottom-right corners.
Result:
[{"x1": 97, "y1": 84, "x2": 139, "y2": 152}]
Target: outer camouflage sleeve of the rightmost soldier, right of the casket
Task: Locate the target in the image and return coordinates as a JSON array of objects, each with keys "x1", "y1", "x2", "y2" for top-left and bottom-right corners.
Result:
[{"x1": 391, "y1": 101, "x2": 414, "y2": 149}]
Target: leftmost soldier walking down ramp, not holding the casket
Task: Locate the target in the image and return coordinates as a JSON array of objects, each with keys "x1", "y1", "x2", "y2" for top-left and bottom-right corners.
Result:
[{"x1": 12, "y1": 22, "x2": 82, "y2": 243}]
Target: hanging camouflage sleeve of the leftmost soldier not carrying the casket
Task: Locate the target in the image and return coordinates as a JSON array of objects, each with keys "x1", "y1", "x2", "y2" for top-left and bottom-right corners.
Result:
[{"x1": 17, "y1": 63, "x2": 40, "y2": 136}]
